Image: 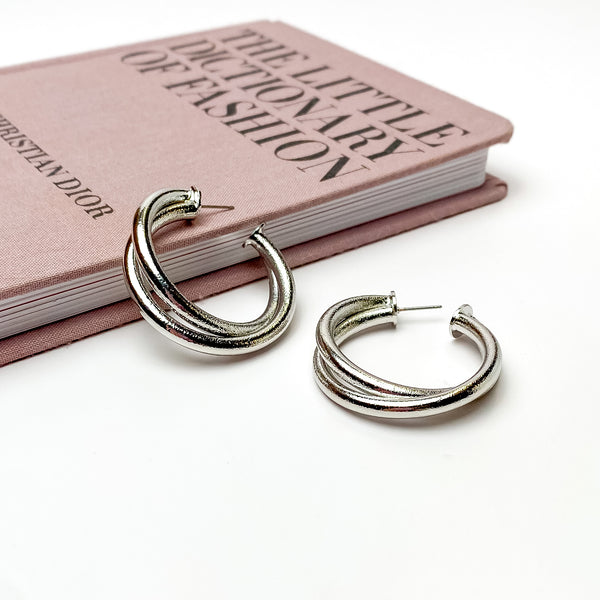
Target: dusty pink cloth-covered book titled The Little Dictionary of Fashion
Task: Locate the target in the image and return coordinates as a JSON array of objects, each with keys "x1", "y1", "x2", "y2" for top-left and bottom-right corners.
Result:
[{"x1": 0, "y1": 21, "x2": 512, "y2": 365}]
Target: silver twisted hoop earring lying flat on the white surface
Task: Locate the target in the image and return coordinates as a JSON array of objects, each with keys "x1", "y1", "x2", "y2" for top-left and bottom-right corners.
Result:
[{"x1": 313, "y1": 292, "x2": 502, "y2": 419}]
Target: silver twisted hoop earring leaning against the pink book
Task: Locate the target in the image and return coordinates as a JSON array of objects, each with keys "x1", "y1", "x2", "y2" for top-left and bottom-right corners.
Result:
[{"x1": 123, "y1": 187, "x2": 296, "y2": 355}]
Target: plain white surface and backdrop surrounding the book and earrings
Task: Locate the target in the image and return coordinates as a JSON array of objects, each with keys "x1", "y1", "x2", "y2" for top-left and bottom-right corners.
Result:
[{"x1": 0, "y1": 0, "x2": 600, "y2": 600}]
